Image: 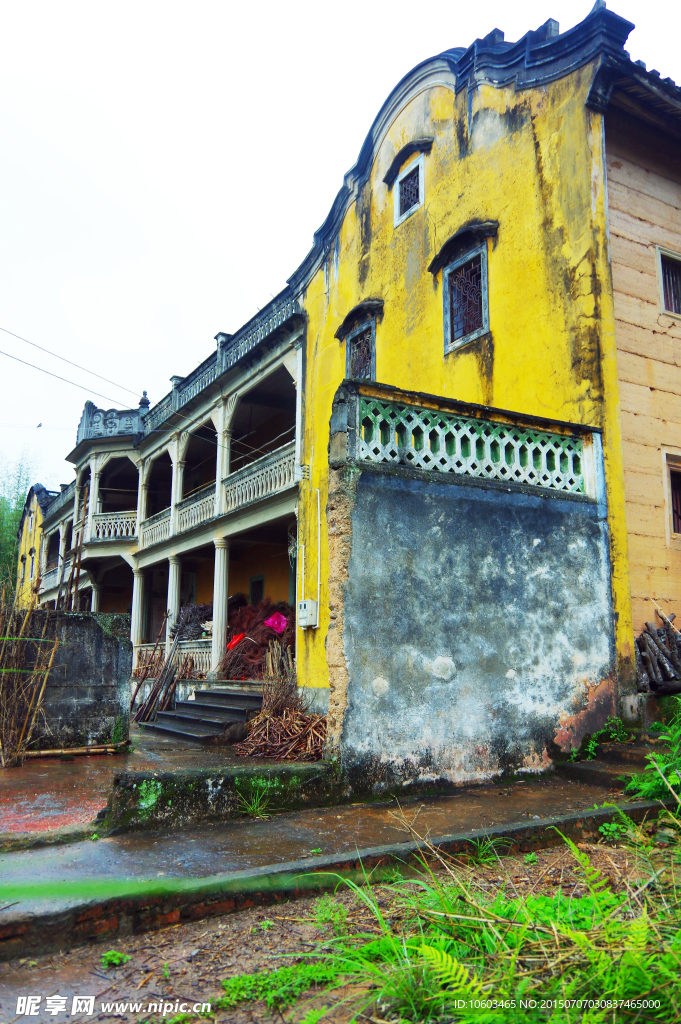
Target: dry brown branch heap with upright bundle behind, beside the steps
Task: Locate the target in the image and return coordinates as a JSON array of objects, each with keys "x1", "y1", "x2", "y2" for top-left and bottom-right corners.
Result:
[{"x1": 235, "y1": 640, "x2": 327, "y2": 761}]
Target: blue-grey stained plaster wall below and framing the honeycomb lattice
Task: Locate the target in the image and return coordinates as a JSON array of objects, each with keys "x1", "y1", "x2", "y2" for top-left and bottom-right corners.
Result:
[{"x1": 328, "y1": 385, "x2": 616, "y2": 792}]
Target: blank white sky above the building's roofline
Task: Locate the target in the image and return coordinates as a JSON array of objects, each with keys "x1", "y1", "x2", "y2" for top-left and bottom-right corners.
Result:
[{"x1": 0, "y1": 0, "x2": 681, "y2": 487}]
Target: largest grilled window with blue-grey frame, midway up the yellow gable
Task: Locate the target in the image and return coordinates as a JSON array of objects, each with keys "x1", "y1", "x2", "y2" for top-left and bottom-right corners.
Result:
[{"x1": 442, "y1": 245, "x2": 490, "y2": 352}]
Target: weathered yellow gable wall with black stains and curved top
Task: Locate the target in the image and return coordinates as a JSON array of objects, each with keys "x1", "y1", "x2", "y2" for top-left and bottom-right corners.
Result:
[{"x1": 297, "y1": 59, "x2": 631, "y2": 686}]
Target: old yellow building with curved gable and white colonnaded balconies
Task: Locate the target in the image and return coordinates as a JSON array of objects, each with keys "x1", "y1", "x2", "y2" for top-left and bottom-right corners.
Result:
[{"x1": 37, "y1": 0, "x2": 681, "y2": 791}]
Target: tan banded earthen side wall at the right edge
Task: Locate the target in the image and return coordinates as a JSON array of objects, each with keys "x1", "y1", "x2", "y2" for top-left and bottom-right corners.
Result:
[{"x1": 605, "y1": 109, "x2": 681, "y2": 633}]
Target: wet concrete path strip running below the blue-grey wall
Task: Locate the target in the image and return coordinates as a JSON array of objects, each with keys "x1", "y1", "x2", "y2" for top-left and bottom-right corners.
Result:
[{"x1": 0, "y1": 775, "x2": 623, "y2": 922}]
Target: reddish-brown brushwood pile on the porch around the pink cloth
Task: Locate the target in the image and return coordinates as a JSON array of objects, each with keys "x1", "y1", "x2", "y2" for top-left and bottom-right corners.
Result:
[{"x1": 218, "y1": 601, "x2": 296, "y2": 679}]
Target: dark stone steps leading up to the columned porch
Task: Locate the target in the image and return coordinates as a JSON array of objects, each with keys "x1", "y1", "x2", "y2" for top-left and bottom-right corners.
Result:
[{"x1": 143, "y1": 686, "x2": 262, "y2": 743}]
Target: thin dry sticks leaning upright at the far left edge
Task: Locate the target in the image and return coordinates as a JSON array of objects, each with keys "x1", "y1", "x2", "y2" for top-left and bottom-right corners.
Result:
[{"x1": 0, "y1": 587, "x2": 58, "y2": 768}]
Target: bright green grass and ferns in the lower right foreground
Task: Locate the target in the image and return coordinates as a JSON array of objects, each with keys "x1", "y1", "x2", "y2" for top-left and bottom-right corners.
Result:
[{"x1": 220, "y1": 813, "x2": 681, "y2": 1024}]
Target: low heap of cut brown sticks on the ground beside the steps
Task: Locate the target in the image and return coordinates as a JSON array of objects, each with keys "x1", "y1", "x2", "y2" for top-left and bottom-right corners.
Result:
[{"x1": 233, "y1": 708, "x2": 327, "y2": 761}]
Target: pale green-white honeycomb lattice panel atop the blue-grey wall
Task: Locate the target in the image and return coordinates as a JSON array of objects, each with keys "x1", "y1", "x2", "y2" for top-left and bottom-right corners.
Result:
[{"x1": 358, "y1": 397, "x2": 586, "y2": 494}]
